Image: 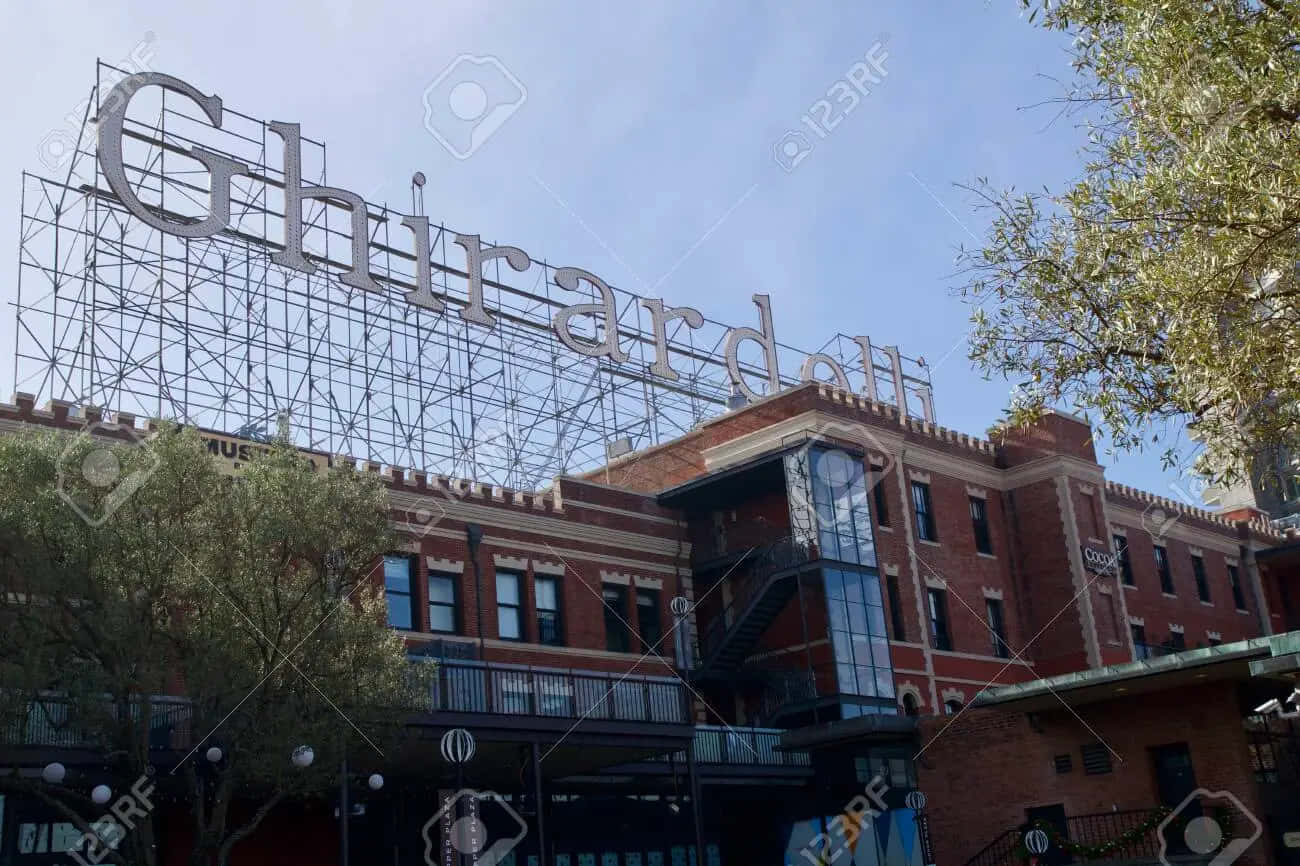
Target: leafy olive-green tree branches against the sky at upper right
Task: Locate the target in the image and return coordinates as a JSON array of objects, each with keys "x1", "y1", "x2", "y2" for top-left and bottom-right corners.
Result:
[{"x1": 961, "y1": 0, "x2": 1300, "y2": 481}]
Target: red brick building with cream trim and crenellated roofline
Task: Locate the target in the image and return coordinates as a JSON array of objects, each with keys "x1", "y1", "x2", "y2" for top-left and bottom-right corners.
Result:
[{"x1": 0, "y1": 384, "x2": 1300, "y2": 866}]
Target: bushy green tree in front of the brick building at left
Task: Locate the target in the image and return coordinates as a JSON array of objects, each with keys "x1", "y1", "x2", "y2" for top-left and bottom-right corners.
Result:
[{"x1": 0, "y1": 426, "x2": 423, "y2": 866}]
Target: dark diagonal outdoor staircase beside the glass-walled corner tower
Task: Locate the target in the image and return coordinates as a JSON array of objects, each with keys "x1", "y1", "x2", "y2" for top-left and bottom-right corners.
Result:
[{"x1": 696, "y1": 538, "x2": 815, "y2": 679}]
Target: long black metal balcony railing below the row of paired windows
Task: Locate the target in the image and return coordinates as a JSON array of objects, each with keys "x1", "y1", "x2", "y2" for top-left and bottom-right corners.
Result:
[{"x1": 428, "y1": 659, "x2": 690, "y2": 724}]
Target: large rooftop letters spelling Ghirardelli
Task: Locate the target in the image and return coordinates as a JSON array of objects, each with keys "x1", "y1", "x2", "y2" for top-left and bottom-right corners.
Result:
[{"x1": 98, "y1": 72, "x2": 933, "y2": 421}]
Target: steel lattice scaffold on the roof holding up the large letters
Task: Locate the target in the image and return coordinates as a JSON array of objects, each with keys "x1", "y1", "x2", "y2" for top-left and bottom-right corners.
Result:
[{"x1": 14, "y1": 64, "x2": 930, "y2": 489}]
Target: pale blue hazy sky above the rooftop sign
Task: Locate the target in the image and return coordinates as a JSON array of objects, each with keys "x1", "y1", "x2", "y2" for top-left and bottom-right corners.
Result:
[{"x1": 0, "y1": 0, "x2": 1196, "y2": 495}]
